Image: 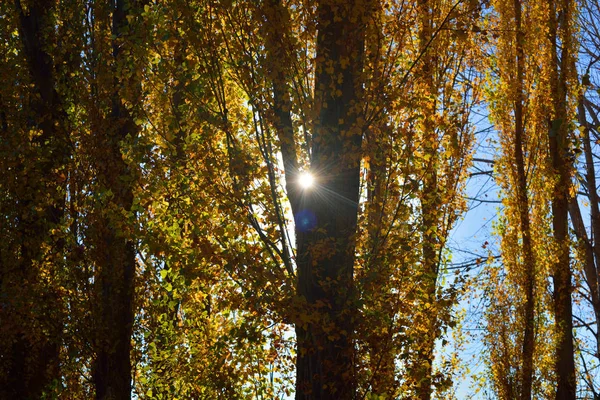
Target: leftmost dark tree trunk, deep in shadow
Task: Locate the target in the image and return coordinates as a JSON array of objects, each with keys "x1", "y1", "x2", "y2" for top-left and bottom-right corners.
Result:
[{"x1": 0, "y1": 0, "x2": 70, "y2": 399}]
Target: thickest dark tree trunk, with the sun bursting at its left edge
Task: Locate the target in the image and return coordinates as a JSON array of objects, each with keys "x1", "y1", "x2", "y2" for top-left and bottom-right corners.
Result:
[{"x1": 295, "y1": 0, "x2": 368, "y2": 400}]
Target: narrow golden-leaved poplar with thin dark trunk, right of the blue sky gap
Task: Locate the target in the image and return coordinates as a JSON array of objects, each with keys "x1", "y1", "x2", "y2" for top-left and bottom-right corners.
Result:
[{"x1": 488, "y1": 1, "x2": 550, "y2": 399}]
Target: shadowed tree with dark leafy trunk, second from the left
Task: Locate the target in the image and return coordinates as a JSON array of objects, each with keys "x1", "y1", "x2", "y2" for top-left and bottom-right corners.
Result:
[{"x1": 89, "y1": 0, "x2": 143, "y2": 399}]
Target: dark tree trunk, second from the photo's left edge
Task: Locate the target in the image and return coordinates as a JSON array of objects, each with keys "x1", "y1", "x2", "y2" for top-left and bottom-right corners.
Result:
[{"x1": 93, "y1": 0, "x2": 138, "y2": 400}]
